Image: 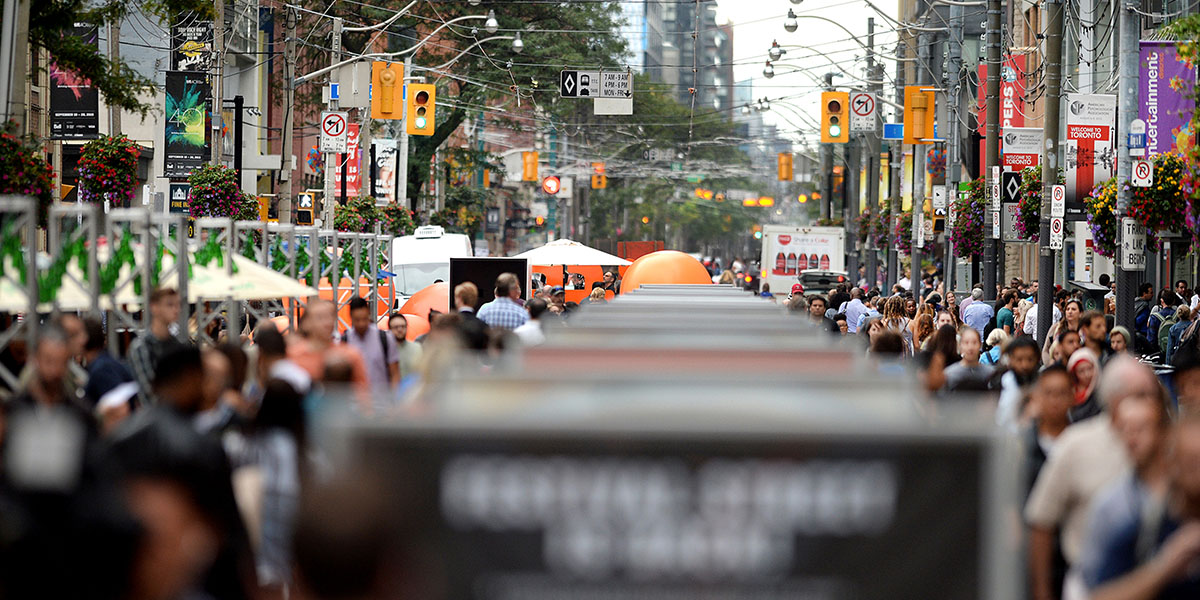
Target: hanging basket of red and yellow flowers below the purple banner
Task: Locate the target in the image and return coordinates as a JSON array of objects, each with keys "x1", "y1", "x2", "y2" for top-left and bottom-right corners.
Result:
[{"x1": 1124, "y1": 154, "x2": 1192, "y2": 251}]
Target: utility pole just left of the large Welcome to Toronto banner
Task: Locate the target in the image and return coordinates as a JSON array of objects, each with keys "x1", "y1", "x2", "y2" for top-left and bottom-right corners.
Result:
[{"x1": 1036, "y1": 0, "x2": 1065, "y2": 342}]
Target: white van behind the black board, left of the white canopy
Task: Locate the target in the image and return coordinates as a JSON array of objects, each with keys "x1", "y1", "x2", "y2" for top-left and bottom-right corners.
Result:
[{"x1": 389, "y1": 226, "x2": 472, "y2": 300}]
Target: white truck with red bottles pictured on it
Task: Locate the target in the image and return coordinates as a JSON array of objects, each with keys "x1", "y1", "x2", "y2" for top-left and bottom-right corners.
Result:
[{"x1": 760, "y1": 224, "x2": 846, "y2": 296}]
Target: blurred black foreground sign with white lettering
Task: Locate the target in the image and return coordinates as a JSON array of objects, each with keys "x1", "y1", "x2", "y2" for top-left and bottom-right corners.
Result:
[{"x1": 350, "y1": 412, "x2": 1018, "y2": 600}]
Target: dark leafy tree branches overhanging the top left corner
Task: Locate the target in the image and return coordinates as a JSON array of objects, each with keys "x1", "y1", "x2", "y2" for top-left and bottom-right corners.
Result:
[{"x1": 29, "y1": 0, "x2": 215, "y2": 116}]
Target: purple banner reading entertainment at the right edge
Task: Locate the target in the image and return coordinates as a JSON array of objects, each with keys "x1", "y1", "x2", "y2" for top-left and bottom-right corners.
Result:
[{"x1": 1138, "y1": 41, "x2": 1196, "y2": 155}]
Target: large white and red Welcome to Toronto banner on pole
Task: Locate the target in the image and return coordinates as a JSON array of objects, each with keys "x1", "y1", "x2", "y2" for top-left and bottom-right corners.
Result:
[{"x1": 1064, "y1": 94, "x2": 1117, "y2": 221}]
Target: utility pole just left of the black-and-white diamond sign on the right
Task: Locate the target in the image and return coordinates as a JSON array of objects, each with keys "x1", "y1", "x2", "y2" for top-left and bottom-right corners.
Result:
[{"x1": 983, "y1": 0, "x2": 1003, "y2": 300}]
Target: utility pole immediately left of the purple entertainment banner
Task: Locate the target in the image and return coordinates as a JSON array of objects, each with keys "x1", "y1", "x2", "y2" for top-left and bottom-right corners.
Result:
[{"x1": 1113, "y1": 0, "x2": 1132, "y2": 331}]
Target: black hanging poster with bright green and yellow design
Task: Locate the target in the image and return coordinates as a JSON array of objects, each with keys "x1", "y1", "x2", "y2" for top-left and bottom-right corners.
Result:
[{"x1": 163, "y1": 71, "x2": 212, "y2": 179}]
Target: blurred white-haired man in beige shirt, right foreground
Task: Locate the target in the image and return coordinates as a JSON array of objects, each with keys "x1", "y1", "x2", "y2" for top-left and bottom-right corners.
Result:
[{"x1": 1025, "y1": 356, "x2": 1160, "y2": 600}]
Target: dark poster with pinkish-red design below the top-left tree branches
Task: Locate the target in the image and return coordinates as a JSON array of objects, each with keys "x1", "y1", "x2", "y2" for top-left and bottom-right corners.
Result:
[{"x1": 49, "y1": 23, "x2": 100, "y2": 139}]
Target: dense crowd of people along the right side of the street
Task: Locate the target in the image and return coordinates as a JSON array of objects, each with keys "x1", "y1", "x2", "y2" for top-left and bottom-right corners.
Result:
[{"x1": 786, "y1": 277, "x2": 1200, "y2": 600}]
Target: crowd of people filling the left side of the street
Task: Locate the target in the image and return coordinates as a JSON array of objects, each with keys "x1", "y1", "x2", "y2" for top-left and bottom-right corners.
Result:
[{"x1": 0, "y1": 272, "x2": 619, "y2": 599}]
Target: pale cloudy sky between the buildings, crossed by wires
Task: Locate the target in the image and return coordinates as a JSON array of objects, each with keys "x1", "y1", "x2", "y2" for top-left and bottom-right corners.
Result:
[{"x1": 716, "y1": 0, "x2": 896, "y2": 144}]
